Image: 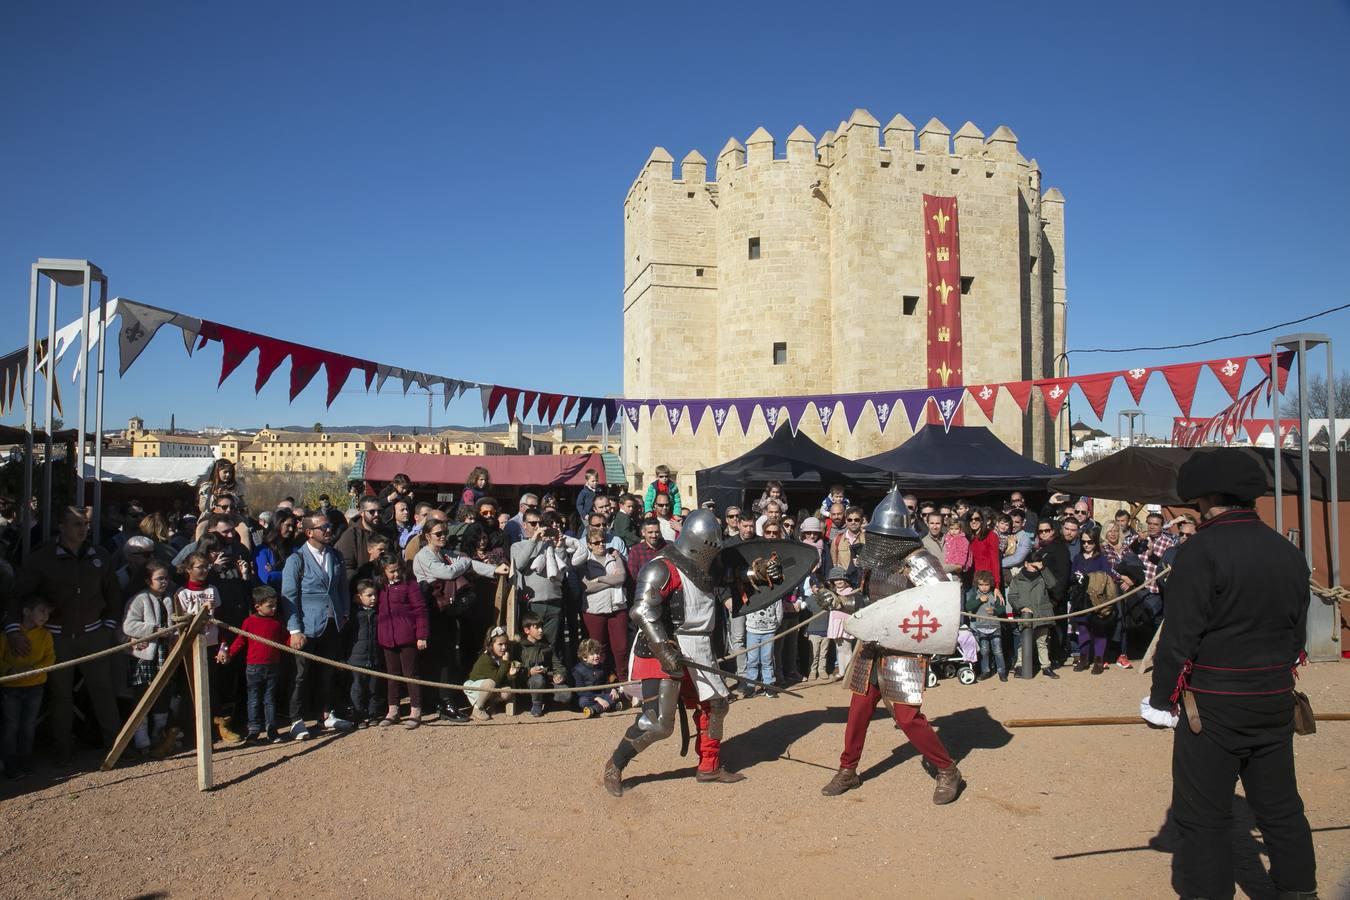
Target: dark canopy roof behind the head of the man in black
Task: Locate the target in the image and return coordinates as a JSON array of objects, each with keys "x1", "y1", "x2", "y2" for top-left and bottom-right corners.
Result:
[{"x1": 1050, "y1": 447, "x2": 1350, "y2": 506}]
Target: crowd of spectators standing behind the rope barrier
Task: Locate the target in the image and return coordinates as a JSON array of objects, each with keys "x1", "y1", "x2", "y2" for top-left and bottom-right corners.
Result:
[{"x1": 0, "y1": 464, "x2": 1195, "y2": 777}]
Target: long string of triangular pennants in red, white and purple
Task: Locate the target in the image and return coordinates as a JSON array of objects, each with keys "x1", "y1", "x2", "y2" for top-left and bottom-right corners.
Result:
[{"x1": 0, "y1": 295, "x2": 1293, "y2": 440}]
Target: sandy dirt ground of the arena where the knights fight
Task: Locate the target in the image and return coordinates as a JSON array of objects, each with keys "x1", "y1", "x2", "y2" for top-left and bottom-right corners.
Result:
[{"x1": 0, "y1": 664, "x2": 1350, "y2": 897}]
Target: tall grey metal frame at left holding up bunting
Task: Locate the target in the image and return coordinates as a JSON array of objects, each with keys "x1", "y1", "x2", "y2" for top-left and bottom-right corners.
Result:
[{"x1": 19, "y1": 258, "x2": 108, "y2": 557}]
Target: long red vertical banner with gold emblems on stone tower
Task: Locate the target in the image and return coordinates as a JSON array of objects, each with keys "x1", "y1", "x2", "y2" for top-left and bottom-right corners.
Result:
[{"x1": 923, "y1": 194, "x2": 965, "y2": 425}]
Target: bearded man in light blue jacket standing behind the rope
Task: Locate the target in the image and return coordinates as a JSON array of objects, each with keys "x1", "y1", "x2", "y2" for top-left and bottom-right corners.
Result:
[{"x1": 281, "y1": 513, "x2": 351, "y2": 741}]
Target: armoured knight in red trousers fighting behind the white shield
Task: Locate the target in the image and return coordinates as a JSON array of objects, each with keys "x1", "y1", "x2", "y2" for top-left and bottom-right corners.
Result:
[{"x1": 807, "y1": 488, "x2": 963, "y2": 804}]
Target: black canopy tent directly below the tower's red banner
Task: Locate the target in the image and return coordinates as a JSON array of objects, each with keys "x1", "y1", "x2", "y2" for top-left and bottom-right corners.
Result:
[{"x1": 859, "y1": 425, "x2": 1064, "y2": 494}]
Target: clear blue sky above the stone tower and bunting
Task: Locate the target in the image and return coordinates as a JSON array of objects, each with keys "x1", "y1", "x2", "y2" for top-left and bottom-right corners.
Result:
[{"x1": 0, "y1": 0, "x2": 1350, "y2": 432}]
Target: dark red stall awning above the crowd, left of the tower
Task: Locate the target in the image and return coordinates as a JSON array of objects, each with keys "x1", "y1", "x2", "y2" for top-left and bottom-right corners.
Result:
[{"x1": 366, "y1": 451, "x2": 605, "y2": 487}]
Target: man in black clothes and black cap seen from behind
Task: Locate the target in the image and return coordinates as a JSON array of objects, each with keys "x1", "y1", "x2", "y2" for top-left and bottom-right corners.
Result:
[{"x1": 1139, "y1": 448, "x2": 1316, "y2": 899}]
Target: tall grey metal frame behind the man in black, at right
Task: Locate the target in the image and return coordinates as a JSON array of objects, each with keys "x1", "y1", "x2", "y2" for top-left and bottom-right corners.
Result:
[{"x1": 1270, "y1": 333, "x2": 1341, "y2": 661}]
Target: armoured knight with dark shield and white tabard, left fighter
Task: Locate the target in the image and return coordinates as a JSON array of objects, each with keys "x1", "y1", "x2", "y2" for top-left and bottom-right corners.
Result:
[{"x1": 605, "y1": 510, "x2": 745, "y2": 797}]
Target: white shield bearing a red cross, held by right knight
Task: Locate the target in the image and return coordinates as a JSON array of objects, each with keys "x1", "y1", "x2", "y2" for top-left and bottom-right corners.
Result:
[{"x1": 844, "y1": 582, "x2": 961, "y2": 656}]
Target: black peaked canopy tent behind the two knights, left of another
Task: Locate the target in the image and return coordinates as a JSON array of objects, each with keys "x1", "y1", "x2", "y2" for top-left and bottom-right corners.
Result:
[{"x1": 695, "y1": 428, "x2": 891, "y2": 510}]
